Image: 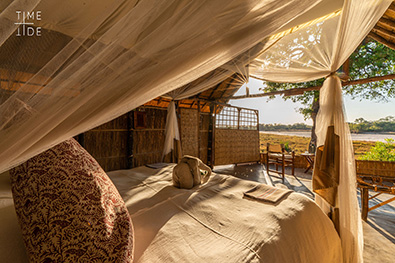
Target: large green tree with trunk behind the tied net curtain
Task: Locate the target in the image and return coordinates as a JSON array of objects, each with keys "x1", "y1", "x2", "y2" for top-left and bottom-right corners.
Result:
[{"x1": 263, "y1": 39, "x2": 395, "y2": 144}]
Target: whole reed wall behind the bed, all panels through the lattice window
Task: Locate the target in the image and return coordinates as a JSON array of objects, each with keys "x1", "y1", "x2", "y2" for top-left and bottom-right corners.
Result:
[{"x1": 78, "y1": 103, "x2": 259, "y2": 171}]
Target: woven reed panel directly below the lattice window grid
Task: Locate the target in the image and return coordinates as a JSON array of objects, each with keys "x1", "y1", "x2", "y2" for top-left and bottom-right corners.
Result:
[{"x1": 214, "y1": 129, "x2": 260, "y2": 165}]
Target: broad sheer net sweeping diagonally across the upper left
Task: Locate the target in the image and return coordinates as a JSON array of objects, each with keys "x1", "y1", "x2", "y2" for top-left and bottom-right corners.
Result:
[{"x1": 0, "y1": 0, "x2": 330, "y2": 174}]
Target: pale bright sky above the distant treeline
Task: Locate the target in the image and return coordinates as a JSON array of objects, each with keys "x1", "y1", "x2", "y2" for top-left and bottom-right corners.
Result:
[{"x1": 229, "y1": 78, "x2": 395, "y2": 125}]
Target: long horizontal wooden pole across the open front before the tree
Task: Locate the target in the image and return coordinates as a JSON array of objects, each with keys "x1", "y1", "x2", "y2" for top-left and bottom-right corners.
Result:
[{"x1": 230, "y1": 74, "x2": 395, "y2": 100}]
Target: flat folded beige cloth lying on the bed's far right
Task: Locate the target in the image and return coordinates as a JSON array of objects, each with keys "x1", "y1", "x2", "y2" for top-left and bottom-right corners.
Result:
[{"x1": 244, "y1": 184, "x2": 292, "y2": 203}]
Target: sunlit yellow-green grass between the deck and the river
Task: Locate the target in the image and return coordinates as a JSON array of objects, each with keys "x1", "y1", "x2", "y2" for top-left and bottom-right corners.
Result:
[{"x1": 259, "y1": 133, "x2": 375, "y2": 159}]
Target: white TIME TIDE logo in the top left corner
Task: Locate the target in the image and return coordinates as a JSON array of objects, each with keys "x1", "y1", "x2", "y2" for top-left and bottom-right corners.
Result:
[{"x1": 15, "y1": 11, "x2": 41, "y2": 37}]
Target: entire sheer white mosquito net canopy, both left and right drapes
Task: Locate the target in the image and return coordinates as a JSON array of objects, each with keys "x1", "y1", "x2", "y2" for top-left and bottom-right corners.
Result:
[{"x1": 0, "y1": 0, "x2": 392, "y2": 262}]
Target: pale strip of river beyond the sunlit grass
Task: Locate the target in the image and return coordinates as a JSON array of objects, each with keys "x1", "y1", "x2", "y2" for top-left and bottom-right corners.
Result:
[{"x1": 261, "y1": 131, "x2": 395, "y2": 142}]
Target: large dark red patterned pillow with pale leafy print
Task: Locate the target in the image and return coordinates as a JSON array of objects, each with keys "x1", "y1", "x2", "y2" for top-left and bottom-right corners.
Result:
[{"x1": 10, "y1": 139, "x2": 133, "y2": 262}]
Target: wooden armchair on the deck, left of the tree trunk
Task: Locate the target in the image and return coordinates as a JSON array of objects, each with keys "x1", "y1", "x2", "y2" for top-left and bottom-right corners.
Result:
[{"x1": 266, "y1": 143, "x2": 295, "y2": 181}]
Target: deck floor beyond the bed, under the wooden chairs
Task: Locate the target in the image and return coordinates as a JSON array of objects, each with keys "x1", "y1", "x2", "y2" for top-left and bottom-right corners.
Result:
[{"x1": 214, "y1": 164, "x2": 395, "y2": 263}]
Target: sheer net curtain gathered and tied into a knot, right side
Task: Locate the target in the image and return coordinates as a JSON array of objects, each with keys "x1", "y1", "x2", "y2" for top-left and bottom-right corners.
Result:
[{"x1": 250, "y1": 0, "x2": 392, "y2": 262}]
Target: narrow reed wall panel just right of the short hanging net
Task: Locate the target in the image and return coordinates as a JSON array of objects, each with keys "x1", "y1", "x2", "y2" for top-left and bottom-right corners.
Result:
[{"x1": 180, "y1": 109, "x2": 199, "y2": 157}]
